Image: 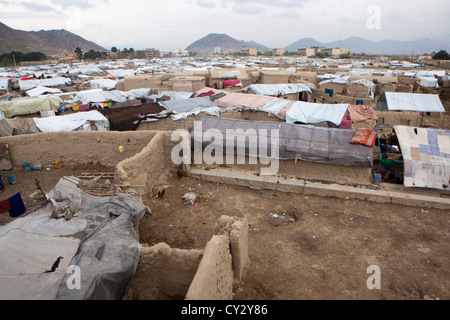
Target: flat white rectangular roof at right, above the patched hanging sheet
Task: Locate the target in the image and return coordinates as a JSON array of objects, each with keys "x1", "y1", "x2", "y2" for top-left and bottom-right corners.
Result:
[{"x1": 377, "y1": 92, "x2": 445, "y2": 113}]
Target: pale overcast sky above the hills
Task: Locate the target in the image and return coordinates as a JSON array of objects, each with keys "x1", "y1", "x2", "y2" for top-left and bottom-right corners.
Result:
[{"x1": 0, "y1": 0, "x2": 450, "y2": 51}]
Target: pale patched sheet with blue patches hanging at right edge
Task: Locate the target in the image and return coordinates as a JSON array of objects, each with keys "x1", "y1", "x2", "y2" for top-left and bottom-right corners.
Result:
[{"x1": 394, "y1": 126, "x2": 450, "y2": 189}]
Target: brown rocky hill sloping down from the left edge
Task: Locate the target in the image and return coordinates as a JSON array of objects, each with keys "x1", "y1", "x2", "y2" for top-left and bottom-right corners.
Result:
[{"x1": 0, "y1": 22, "x2": 107, "y2": 55}]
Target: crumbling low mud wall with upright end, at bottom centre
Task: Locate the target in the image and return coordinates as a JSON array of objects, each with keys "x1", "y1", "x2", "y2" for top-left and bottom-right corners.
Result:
[{"x1": 124, "y1": 216, "x2": 249, "y2": 300}]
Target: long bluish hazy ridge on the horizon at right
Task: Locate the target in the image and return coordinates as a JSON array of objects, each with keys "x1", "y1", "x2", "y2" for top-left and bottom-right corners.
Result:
[{"x1": 286, "y1": 37, "x2": 450, "y2": 55}]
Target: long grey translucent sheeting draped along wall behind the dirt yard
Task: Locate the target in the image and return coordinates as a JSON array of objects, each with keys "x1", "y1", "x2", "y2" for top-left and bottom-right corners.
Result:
[{"x1": 191, "y1": 117, "x2": 373, "y2": 168}]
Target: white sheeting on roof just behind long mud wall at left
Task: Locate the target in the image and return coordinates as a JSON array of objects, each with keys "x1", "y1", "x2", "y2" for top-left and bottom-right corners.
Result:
[{"x1": 34, "y1": 110, "x2": 109, "y2": 132}]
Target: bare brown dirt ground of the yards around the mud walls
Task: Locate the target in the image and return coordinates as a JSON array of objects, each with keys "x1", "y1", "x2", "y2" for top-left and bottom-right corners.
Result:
[{"x1": 0, "y1": 165, "x2": 450, "y2": 300}]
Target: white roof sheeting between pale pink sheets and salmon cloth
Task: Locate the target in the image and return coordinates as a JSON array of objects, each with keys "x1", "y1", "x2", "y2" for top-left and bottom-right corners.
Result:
[{"x1": 286, "y1": 101, "x2": 348, "y2": 126}]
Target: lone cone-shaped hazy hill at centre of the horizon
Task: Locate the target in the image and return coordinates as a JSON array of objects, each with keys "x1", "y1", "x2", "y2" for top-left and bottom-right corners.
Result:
[{"x1": 186, "y1": 33, "x2": 272, "y2": 56}]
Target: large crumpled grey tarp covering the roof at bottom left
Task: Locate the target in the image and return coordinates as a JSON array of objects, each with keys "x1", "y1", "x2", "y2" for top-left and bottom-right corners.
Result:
[{"x1": 0, "y1": 177, "x2": 149, "y2": 300}]
